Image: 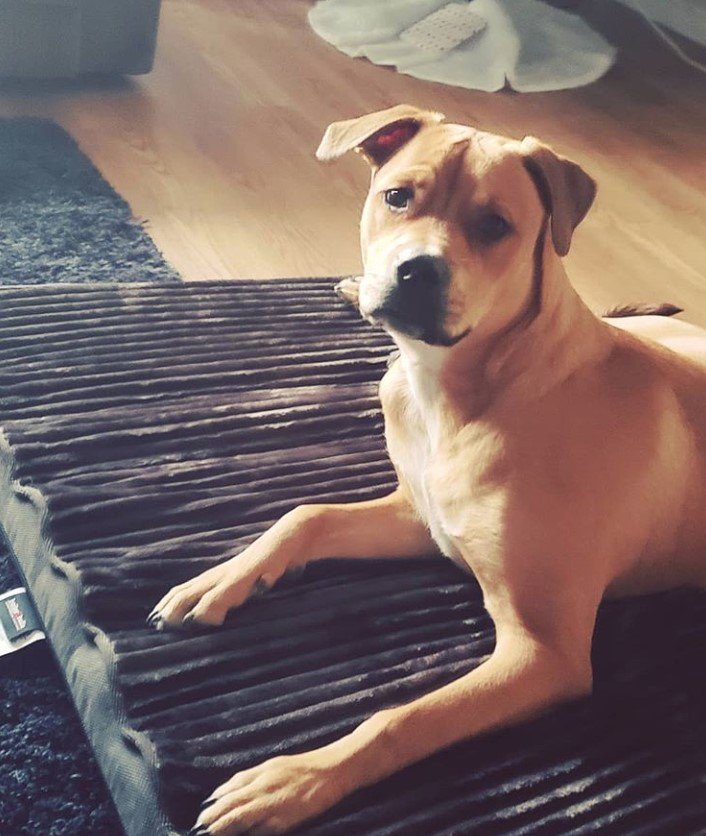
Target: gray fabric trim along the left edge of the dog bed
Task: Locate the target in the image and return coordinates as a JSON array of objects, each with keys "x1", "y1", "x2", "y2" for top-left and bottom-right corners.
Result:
[{"x1": 0, "y1": 435, "x2": 175, "y2": 836}]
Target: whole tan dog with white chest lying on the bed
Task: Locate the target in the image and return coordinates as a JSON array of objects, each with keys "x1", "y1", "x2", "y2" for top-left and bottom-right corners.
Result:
[{"x1": 152, "y1": 106, "x2": 706, "y2": 836}]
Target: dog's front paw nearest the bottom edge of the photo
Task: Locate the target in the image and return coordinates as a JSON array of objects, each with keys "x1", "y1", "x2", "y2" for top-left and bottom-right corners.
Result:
[{"x1": 191, "y1": 751, "x2": 342, "y2": 836}]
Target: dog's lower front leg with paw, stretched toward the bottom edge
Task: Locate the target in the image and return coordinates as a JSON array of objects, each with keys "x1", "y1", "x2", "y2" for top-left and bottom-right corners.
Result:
[{"x1": 190, "y1": 632, "x2": 591, "y2": 836}]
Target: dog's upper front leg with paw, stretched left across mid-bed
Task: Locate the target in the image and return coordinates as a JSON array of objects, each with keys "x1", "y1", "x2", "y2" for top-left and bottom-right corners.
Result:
[{"x1": 149, "y1": 488, "x2": 436, "y2": 629}]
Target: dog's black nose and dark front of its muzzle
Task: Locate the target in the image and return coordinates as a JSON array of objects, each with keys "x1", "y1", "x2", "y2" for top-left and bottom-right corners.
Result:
[{"x1": 367, "y1": 255, "x2": 451, "y2": 345}]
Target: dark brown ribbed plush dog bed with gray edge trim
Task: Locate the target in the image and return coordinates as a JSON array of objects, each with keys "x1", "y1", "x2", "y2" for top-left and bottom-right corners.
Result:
[{"x1": 0, "y1": 279, "x2": 706, "y2": 836}]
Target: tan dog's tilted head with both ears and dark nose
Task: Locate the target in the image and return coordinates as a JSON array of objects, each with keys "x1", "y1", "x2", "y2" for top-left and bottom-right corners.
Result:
[{"x1": 317, "y1": 105, "x2": 595, "y2": 346}]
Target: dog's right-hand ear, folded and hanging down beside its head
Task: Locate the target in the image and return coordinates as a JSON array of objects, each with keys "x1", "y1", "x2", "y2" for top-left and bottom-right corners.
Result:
[{"x1": 520, "y1": 136, "x2": 596, "y2": 256}]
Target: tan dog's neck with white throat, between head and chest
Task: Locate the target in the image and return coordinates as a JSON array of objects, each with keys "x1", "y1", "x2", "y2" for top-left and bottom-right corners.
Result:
[{"x1": 393, "y1": 241, "x2": 613, "y2": 423}]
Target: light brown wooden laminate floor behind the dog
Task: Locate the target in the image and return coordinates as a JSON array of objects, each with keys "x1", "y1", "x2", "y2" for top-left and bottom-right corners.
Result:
[{"x1": 0, "y1": 0, "x2": 706, "y2": 326}]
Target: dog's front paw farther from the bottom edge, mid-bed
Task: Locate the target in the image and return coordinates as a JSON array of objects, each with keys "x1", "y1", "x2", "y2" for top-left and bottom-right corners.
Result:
[{"x1": 147, "y1": 553, "x2": 274, "y2": 630}]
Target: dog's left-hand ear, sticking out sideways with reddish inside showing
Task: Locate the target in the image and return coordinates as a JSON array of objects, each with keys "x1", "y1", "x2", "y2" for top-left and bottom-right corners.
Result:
[{"x1": 316, "y1": 105, "x2": 444, "y2": 168}]
